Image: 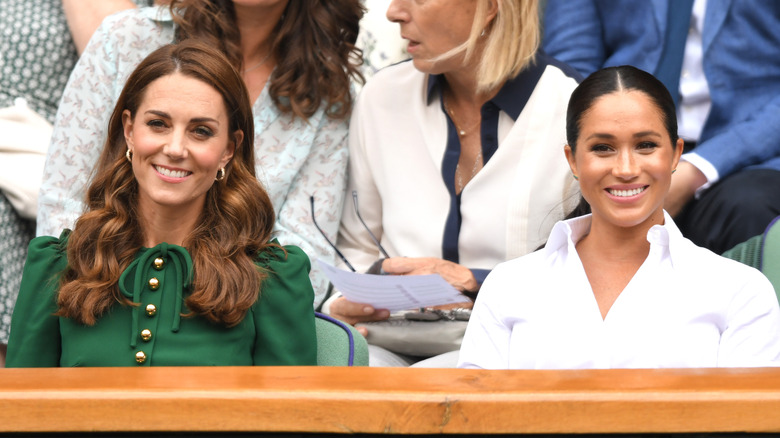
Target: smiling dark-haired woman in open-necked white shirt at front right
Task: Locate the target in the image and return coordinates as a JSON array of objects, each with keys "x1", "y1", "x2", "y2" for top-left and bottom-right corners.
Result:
[{"x1": 459, "y1": 66, "x2": 780, "y2": 369}]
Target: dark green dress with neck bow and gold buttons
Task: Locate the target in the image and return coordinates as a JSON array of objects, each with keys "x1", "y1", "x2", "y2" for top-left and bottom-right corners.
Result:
[{"x1": 6, "y1": 232, "x2": 317, "y2": 367}]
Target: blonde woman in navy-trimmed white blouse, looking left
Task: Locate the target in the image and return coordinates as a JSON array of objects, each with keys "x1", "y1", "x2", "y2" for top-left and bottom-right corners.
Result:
[{"x1": 329, "y1": 0, "x2": 578, "y2": 365}]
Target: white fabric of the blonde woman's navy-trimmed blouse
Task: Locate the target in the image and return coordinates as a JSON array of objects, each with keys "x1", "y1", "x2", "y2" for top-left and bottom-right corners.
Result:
[{"x1": 337, "y1": 60, "x2": 579, "y2": 271}]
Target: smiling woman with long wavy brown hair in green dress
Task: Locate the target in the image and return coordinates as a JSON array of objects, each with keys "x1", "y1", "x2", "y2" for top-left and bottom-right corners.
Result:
[{"x1": 7, "y1": 41, "x2": 316, "y2": 367}]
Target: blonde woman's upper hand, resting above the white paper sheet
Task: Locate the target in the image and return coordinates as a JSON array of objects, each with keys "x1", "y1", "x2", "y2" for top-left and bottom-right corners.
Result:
[{"x1": 382, "y1": 257, "x2": 479, "y2": 292}]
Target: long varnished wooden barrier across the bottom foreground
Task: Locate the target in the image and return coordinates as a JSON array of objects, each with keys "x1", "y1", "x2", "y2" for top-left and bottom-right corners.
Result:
[{"x1": 0, "y1": 367, "x2": 780, "y2": 434}]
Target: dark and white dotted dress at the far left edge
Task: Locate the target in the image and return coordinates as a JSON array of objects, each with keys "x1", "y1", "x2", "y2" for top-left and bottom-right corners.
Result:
[{"x1": 0, "y1": 0, "x2": 78, "y2": 344}]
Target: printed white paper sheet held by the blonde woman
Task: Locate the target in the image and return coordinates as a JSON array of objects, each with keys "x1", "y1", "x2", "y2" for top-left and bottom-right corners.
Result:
[{"x1": 317, "y1": 260, "x2": 468, "y2": 312}]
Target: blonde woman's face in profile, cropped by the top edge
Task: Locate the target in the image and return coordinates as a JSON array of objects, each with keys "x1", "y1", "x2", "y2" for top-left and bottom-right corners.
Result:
[{"x1": 387, "y1": 0, "x2": 476, "y2": 74}]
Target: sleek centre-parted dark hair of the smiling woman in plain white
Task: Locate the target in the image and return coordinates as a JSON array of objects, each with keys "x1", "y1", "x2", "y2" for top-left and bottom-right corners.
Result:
[{"x1": 566, "y1": 65, "x2": 677, "y2": 152}]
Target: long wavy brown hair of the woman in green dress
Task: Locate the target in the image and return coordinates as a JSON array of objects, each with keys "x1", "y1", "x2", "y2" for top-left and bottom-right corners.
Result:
[{"x1": 57, "y1": 41, "x2": 275, "y2": 327}]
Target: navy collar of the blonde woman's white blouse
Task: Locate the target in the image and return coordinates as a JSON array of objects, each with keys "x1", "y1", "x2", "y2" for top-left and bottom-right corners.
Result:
[{"x1": 426, "y1": 57, "x2": 547, "y2": 120}]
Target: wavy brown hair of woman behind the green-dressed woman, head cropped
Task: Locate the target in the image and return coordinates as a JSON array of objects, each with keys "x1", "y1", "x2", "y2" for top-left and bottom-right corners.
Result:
[{"x1": 170, "y1": 0, "x2": 364, "y2": 119}]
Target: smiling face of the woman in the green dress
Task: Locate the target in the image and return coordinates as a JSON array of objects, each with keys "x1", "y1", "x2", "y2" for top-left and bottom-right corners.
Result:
[{"x1": 122, "y1": 73, "x2": 236, "y2": 221}]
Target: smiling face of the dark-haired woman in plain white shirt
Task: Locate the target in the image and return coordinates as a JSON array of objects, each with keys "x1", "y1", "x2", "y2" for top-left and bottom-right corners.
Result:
[{"x1": 566, "y1": 90, "x2": 682, "y2": 228}]
